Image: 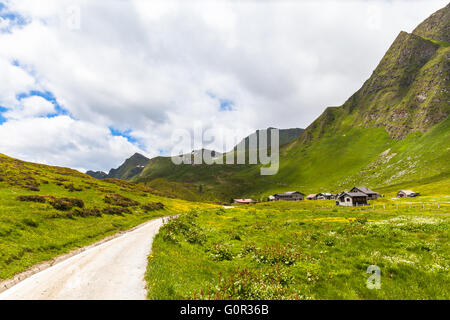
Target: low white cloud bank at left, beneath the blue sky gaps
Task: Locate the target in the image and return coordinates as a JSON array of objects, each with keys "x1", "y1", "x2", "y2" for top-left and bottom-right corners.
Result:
[{"x1": 0, "y1": 116, "x2": 143, "y2": 171}]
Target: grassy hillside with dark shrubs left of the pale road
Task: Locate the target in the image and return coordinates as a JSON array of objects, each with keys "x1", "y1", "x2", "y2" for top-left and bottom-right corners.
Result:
[{"x1": 0, "y1": 154, "x2": 214, "y2": 279}]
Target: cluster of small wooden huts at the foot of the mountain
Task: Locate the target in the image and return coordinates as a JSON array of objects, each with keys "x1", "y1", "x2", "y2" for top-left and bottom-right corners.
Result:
[{"x1": 233, "y1": 187, "x2": 420, "y2": 207}]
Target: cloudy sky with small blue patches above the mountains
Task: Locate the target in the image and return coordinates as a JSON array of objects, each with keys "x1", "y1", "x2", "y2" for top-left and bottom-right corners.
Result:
[{"x1": 0, "y1": 0, "x2": 448, "y2": 171}]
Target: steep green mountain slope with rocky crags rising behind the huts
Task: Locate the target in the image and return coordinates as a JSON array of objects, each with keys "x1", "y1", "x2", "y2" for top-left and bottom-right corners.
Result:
[{"x1": 133, "y1": 5, "x2": 450, "y2": 200}]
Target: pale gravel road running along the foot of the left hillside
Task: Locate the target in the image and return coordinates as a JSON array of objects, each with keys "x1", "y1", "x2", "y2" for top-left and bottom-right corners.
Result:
[{"x1": 0, "y1": 218, "x2": 163, "y2": 300}]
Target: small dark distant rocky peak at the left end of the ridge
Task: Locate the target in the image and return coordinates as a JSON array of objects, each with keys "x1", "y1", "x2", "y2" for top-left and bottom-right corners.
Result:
[{"x1": 86, "y1": 153, "x2": 150, "y2": 180}]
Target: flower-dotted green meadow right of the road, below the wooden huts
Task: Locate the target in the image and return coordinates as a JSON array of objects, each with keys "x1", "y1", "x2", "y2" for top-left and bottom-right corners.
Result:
[{"x1": 146, "y1": 197, "x2": 450, "y2": 299}]
